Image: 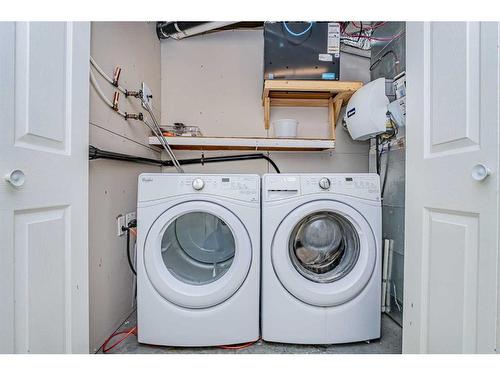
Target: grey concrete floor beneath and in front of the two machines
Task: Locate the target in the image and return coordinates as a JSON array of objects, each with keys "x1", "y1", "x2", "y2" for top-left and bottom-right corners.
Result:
[{"x1": 99, "y1": 312, "x2": 401, "y2": 354}]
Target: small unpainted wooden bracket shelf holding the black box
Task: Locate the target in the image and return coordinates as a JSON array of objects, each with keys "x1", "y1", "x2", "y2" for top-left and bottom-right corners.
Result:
[{"x1": 262, "y1": 79, "x2": 363, "y2": 140}]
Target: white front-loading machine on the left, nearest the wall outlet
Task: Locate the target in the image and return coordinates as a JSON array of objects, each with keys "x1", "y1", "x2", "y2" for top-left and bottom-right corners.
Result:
[{"x1": 137, "y1": 173, "x2": 260, "y2": 346}]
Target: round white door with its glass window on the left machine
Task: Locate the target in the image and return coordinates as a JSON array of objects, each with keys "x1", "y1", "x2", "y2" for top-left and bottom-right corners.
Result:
[{"x1": 143, "y1": 201, "x2": 252, "y2": 308}]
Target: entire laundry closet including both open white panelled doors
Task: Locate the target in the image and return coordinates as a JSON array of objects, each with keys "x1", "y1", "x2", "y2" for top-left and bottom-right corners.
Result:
[{"x1": 0, "y1": 21, "x2": 500, "y2": 354}]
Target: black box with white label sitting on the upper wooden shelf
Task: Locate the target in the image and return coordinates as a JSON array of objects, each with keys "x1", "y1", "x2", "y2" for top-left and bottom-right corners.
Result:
[{"x1": 264, "y1": 22, "x2": 340, "y2": 80}]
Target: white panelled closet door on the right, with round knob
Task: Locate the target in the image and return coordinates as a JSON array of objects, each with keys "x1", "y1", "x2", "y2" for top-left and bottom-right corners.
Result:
[{"x1": 403, "y1": 22, "x2": 500, "y2": 353}]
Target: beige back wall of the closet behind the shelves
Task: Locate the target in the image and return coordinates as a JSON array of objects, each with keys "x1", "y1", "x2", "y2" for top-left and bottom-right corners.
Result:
[{"x1": 161, "y1": 29, "x2": 370, "y2": 173}]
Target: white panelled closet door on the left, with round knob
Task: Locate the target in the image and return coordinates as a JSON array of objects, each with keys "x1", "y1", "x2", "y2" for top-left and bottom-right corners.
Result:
[{"x1": 0, "y1": 22, "x2": 90, "y2": 353}]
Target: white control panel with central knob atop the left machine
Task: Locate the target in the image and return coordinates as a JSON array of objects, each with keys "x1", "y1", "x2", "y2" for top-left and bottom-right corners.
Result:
[{"x1": 139, "y1": 173, "x2": 260, "y2": 202}]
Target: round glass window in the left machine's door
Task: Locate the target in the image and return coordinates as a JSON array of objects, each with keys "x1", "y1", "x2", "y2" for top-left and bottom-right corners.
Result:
[{"x1": 161, "y1": 212, "x2": 235, "y2": 285}]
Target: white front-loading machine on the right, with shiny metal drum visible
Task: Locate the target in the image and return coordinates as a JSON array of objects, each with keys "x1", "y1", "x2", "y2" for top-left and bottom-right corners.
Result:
[{"x1": 261, "y1": 174, "x2": 382, "y2": 344}]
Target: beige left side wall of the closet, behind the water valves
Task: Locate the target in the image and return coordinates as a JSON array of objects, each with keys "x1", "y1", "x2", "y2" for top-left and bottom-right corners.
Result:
[{"x1": 89, "y1": 22, "x2": 161, "y2": 352}]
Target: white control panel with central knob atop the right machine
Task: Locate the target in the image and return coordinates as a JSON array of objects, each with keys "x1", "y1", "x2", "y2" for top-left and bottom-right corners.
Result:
[{"x1": 263, "y1": 173, "x2": 380, "y2": 201}]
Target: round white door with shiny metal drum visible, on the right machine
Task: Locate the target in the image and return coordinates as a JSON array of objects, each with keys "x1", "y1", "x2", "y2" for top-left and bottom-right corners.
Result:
[{"x1": 271, "y1": 200, "x2": 377, "y2": 306}]
